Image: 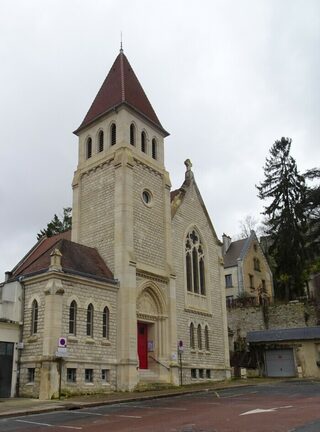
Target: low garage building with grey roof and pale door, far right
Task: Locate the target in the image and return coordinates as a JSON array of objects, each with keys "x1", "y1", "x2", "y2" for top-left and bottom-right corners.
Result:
[{"x1": 247, "y1": 327, "x2": 320, "y2": 378}]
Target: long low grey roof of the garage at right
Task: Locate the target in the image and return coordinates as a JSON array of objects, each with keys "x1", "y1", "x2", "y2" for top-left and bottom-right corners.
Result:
[{"x1": 247, "y1": 327, "x2": 320, "y2": 343}]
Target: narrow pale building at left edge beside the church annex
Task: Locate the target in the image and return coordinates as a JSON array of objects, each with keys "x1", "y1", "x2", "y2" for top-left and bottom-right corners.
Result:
[{"x1": 0, "y1": 276, "x2": 23, "y2": 398}]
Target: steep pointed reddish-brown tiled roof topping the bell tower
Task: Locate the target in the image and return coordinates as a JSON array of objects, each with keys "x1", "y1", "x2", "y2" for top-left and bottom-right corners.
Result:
[{"x1": 74, "y1": 50, "x2": 168, "y2": 135}]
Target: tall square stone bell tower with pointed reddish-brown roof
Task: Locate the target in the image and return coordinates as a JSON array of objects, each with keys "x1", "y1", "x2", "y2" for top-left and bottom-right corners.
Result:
[{"x1": 72, "y1": 48, "x2": 176, "y2": 390}]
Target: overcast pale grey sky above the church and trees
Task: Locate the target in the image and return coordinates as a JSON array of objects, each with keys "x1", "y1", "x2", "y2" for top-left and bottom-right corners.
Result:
[{"x1": 0, "y1": 0, "x2": 320, "y2": 281}]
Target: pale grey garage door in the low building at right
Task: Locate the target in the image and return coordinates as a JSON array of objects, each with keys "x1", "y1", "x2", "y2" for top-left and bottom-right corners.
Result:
[{"x1": 266, "y1": 349, "x2": 296, "y2": 377}]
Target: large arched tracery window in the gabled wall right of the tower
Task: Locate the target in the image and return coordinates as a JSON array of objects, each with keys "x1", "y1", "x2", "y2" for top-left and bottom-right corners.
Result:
[{"x1": 185, "y1": 230, "x2": 206, "y2": 295}]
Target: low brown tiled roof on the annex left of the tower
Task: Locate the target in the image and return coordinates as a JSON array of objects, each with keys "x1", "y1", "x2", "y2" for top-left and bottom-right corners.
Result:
[{"x1": 13, "y1": 231, "x2": 114, "y2": 280}]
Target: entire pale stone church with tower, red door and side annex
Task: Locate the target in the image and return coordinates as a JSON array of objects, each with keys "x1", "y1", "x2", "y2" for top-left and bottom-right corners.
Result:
[{"x1": 3, "y1": 49, "x2": 230, "y2": 399}]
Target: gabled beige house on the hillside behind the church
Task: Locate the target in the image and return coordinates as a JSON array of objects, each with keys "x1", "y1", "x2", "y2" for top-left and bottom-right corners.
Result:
[{"x1": 223, "y1": 231, "x2": 273, "y2": 304}]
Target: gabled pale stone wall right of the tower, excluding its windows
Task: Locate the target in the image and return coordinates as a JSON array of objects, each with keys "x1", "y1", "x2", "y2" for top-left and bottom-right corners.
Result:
[{"x1": 172, "y1": 177, "x2": 228, "y2": 382}]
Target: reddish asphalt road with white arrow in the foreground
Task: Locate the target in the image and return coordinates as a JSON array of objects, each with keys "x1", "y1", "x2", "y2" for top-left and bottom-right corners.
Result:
[{"x1": 0, "y1": 381, "x2": 320, "y2": 432}]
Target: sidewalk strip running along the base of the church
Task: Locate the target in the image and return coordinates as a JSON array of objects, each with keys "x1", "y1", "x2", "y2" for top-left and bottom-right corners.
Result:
[{"x1": 0, "y1": 378, "x2": 279, "y2": 418}]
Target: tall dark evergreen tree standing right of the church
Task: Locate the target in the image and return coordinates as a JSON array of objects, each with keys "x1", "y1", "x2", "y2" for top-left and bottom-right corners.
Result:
[{"x1": 256, "y1": 138, "x2": 306, "y2": 300}]
